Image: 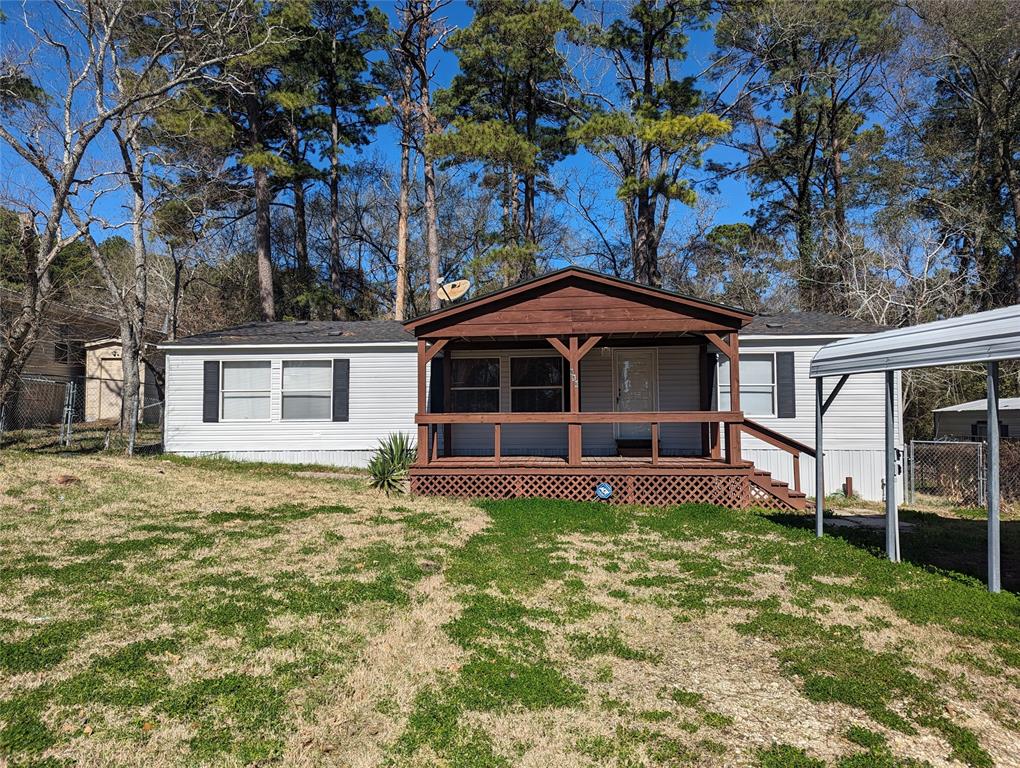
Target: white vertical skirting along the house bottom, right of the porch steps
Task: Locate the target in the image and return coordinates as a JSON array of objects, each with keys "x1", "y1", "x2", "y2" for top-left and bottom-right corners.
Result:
[{"x1": 741, "y1": 447, "x2": 904, "y2": 502}]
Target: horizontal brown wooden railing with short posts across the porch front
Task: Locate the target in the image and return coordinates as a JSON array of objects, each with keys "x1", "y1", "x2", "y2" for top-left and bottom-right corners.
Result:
[{"x1": 415, "y1": 411, "x2": 744, "y2": 465}]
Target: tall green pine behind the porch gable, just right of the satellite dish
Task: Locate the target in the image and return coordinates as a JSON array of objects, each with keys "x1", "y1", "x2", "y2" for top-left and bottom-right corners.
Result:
[{"x1": 429, "y1": 0, "x2": 576, "y2": 283}]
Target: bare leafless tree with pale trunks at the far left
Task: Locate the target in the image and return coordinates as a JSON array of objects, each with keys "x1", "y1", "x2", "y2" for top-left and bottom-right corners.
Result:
[{"x1": 0, "y1": 0, "x2": 287, "y2": 442}]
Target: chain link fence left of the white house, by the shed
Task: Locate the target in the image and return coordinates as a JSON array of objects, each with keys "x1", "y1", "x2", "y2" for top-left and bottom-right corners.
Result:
[{"x1": 0, "y1": 374, "x2": 163, "y2": 453}]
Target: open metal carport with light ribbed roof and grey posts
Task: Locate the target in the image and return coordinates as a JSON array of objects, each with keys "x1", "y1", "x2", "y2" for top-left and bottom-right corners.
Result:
[{"x1": 811, "y1": 305, "x2": 1020, "y2": 592}]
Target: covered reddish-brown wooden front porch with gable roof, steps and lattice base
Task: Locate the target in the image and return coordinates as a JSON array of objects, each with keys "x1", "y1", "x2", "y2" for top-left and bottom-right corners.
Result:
[{"x1": 408, "y1": 268, "x2": 810, "y2": 508}]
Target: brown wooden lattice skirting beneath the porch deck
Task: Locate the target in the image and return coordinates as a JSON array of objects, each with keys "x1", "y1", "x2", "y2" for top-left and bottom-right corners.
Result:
[{"x1": 411, "y1": 471, "x2": 787, "y2": 508}]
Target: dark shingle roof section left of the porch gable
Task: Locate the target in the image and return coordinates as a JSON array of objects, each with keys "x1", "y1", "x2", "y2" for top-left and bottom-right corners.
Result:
[{"x1": 165, "y1": 320, "x2": 414, "y2": 347}]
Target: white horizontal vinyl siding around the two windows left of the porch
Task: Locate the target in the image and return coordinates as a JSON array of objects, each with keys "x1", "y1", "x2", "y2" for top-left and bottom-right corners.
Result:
[{"x1": 164, "y1": 344, "x2": 417, "y2": 466}]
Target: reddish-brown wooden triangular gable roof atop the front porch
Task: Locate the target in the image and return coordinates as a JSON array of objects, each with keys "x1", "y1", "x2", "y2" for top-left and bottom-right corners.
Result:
[{"x1": 404, "y1": 266, "x2": 753, "y2": 338}]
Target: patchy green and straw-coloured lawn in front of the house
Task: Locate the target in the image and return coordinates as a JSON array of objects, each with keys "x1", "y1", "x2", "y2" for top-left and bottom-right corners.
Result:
[{"x1": 0, "y1": 451, "x2": 1020, "y2": 768}]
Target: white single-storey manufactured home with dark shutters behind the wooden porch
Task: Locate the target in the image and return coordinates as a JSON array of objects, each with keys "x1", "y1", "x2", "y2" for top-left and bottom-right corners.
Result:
[{"x1": 162, "y1": 269, "x2": 899, "y2": 500}]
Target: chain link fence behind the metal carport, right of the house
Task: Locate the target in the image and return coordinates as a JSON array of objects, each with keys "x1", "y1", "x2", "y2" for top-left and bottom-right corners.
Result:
[{"x1": 907, "y1": 440, "x2": 1020, "y2": 507}]
